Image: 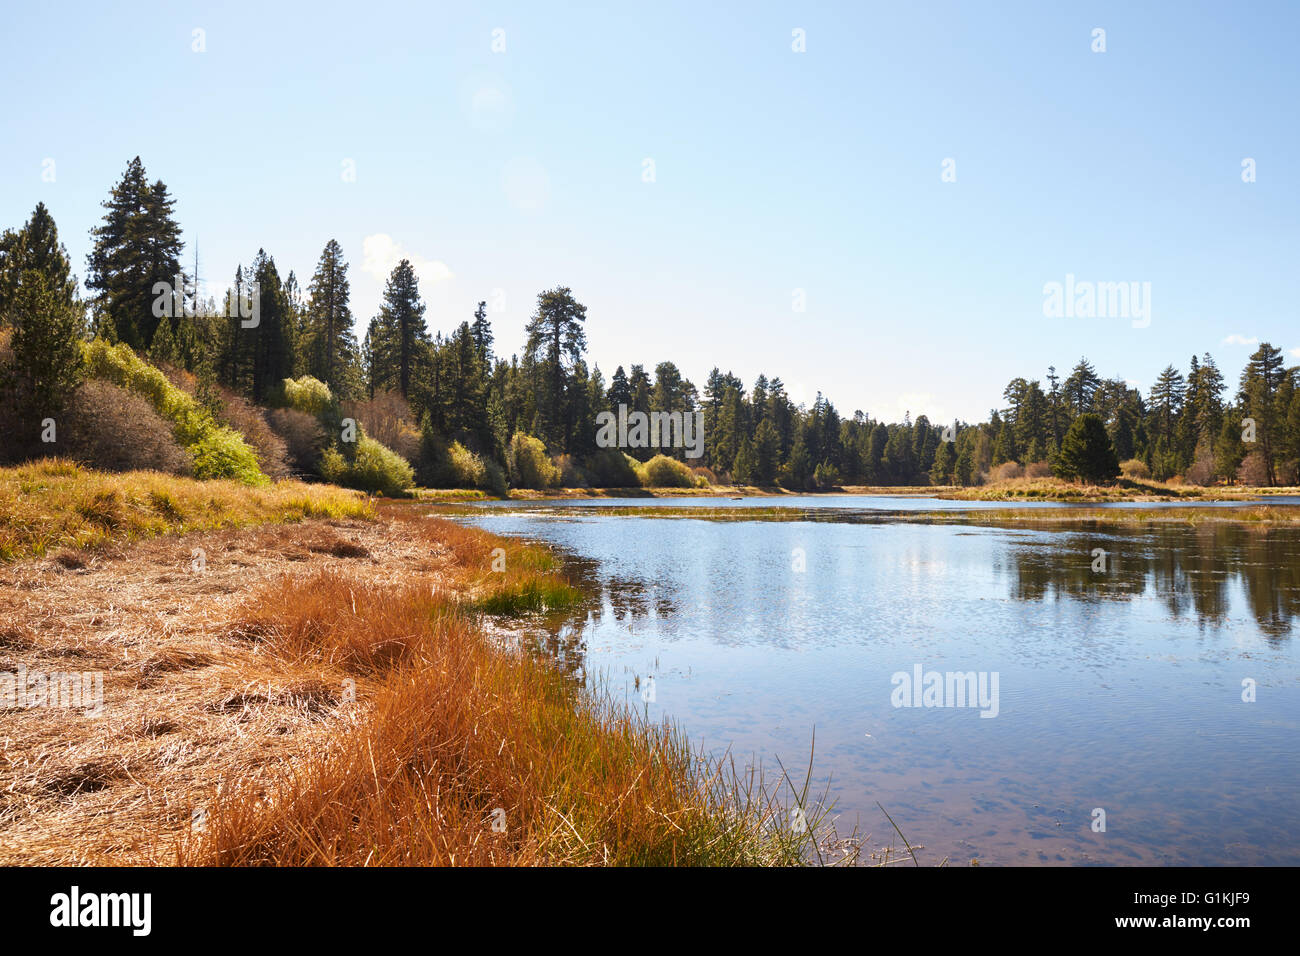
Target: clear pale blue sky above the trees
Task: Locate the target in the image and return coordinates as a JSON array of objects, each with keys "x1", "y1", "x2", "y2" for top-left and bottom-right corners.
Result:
[{"x1": 0, "y1": 3, "x2": 1300, "y2": 420}]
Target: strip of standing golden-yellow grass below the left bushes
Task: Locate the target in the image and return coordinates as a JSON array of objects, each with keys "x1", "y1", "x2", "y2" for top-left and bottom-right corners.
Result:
[{"x1": 0, "y1": 459, "x2": 374, "y2": 561}]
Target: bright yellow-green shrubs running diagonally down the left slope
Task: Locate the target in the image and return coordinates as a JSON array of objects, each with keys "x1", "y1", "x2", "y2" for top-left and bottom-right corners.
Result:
[{"x1": 85, "y1": 338, "x2": 267, "y2": 485}]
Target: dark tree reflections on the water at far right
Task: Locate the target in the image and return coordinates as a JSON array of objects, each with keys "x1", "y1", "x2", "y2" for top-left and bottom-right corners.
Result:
[{"x1": 1009, "y1": 523, "x2": 1300, "y2": 637}]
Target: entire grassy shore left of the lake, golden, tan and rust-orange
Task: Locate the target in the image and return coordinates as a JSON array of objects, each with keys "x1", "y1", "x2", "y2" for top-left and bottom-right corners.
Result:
[{"x1": 0, "y1": 463, "x2": 818, "y2": 865}]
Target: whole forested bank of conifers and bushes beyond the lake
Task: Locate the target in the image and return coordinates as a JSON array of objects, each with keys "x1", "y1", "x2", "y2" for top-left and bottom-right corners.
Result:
[{"x1": 0, "y1": 157, "x2": 1300, "y2": 493}]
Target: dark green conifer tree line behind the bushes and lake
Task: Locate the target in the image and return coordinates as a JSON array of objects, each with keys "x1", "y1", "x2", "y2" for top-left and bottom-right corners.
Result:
[{"x1": 0, "y1": 157, "x2": 1300, "y2": 489}]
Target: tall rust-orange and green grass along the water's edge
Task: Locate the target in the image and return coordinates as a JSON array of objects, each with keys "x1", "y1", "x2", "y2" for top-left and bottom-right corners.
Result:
[{"x1": 178, "y1": 519, "x2": 820, "y2": 865}]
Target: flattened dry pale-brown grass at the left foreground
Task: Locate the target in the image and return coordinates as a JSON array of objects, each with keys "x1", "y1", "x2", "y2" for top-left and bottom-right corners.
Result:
[{"x1": 0, "y1": 519, "x2": 395, "y2": 865}]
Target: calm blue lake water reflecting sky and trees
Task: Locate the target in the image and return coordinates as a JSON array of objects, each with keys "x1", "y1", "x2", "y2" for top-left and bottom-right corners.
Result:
[{"x1": 452, "y1": 497, "x2": 1300, "y2": 865}]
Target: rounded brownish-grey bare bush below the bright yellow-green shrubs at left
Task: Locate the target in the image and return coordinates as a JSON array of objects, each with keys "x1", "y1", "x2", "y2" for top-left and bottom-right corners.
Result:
[{"x1": 56, "y1": 378, "x2": 191, "y2": 475}]
